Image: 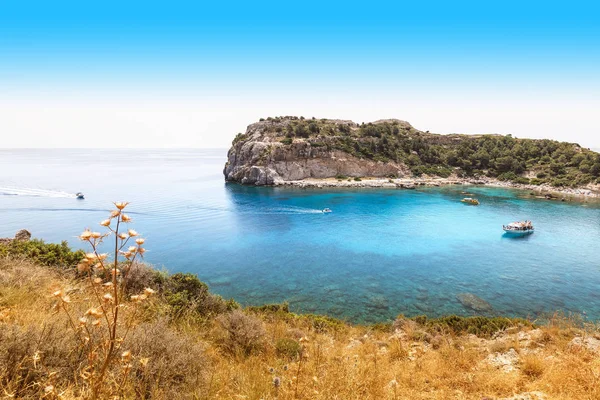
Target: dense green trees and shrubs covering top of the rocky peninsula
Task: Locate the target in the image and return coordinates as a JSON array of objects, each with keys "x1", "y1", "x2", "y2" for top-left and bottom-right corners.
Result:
[{"x1": 247, "y1": 117, "x2": 600, "y2": 186}]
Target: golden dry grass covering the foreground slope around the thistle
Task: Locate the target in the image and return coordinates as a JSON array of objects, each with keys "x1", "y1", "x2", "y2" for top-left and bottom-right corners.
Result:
[{"x1": 0, "y1": 258, "x2": 600, "y2": 400}]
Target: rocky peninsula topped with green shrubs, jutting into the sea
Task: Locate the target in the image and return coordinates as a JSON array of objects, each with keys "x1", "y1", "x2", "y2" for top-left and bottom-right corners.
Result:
[{"x1": 223, "y1": 117, "x2": 600, "y2": 198}]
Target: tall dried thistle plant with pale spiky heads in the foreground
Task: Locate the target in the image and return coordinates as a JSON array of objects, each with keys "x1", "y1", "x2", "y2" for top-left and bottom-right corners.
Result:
[{"x1": 53, "y1": 202, "x2": 155, "y2": 399}]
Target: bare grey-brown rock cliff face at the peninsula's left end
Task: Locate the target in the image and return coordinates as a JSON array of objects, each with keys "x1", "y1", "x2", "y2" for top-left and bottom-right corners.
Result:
[{"x1": 223, "y1": 119, "x2": 410, "y2": 185}]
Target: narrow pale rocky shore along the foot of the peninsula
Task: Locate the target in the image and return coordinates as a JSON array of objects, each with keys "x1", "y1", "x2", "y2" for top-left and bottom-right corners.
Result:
[{"x1": 275, "y1": 177, "x2": 600, "y2": 199}]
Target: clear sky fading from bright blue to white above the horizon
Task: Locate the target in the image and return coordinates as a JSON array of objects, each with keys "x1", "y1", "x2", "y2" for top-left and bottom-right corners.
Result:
[{"x1": 0, "y1": 0, "x2": 600, "y2": 148}]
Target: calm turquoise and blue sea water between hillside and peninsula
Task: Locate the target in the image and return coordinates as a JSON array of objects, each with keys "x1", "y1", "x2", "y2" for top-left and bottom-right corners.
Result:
[{"x1": 0, "y1": 150, "x2": 600, "y2": 322}]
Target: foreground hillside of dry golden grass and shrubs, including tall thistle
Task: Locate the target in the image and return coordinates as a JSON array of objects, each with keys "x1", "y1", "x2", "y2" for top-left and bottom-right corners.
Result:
[{"x1": 0, "y1": 203, "x2": 600, "y2": 400}]
